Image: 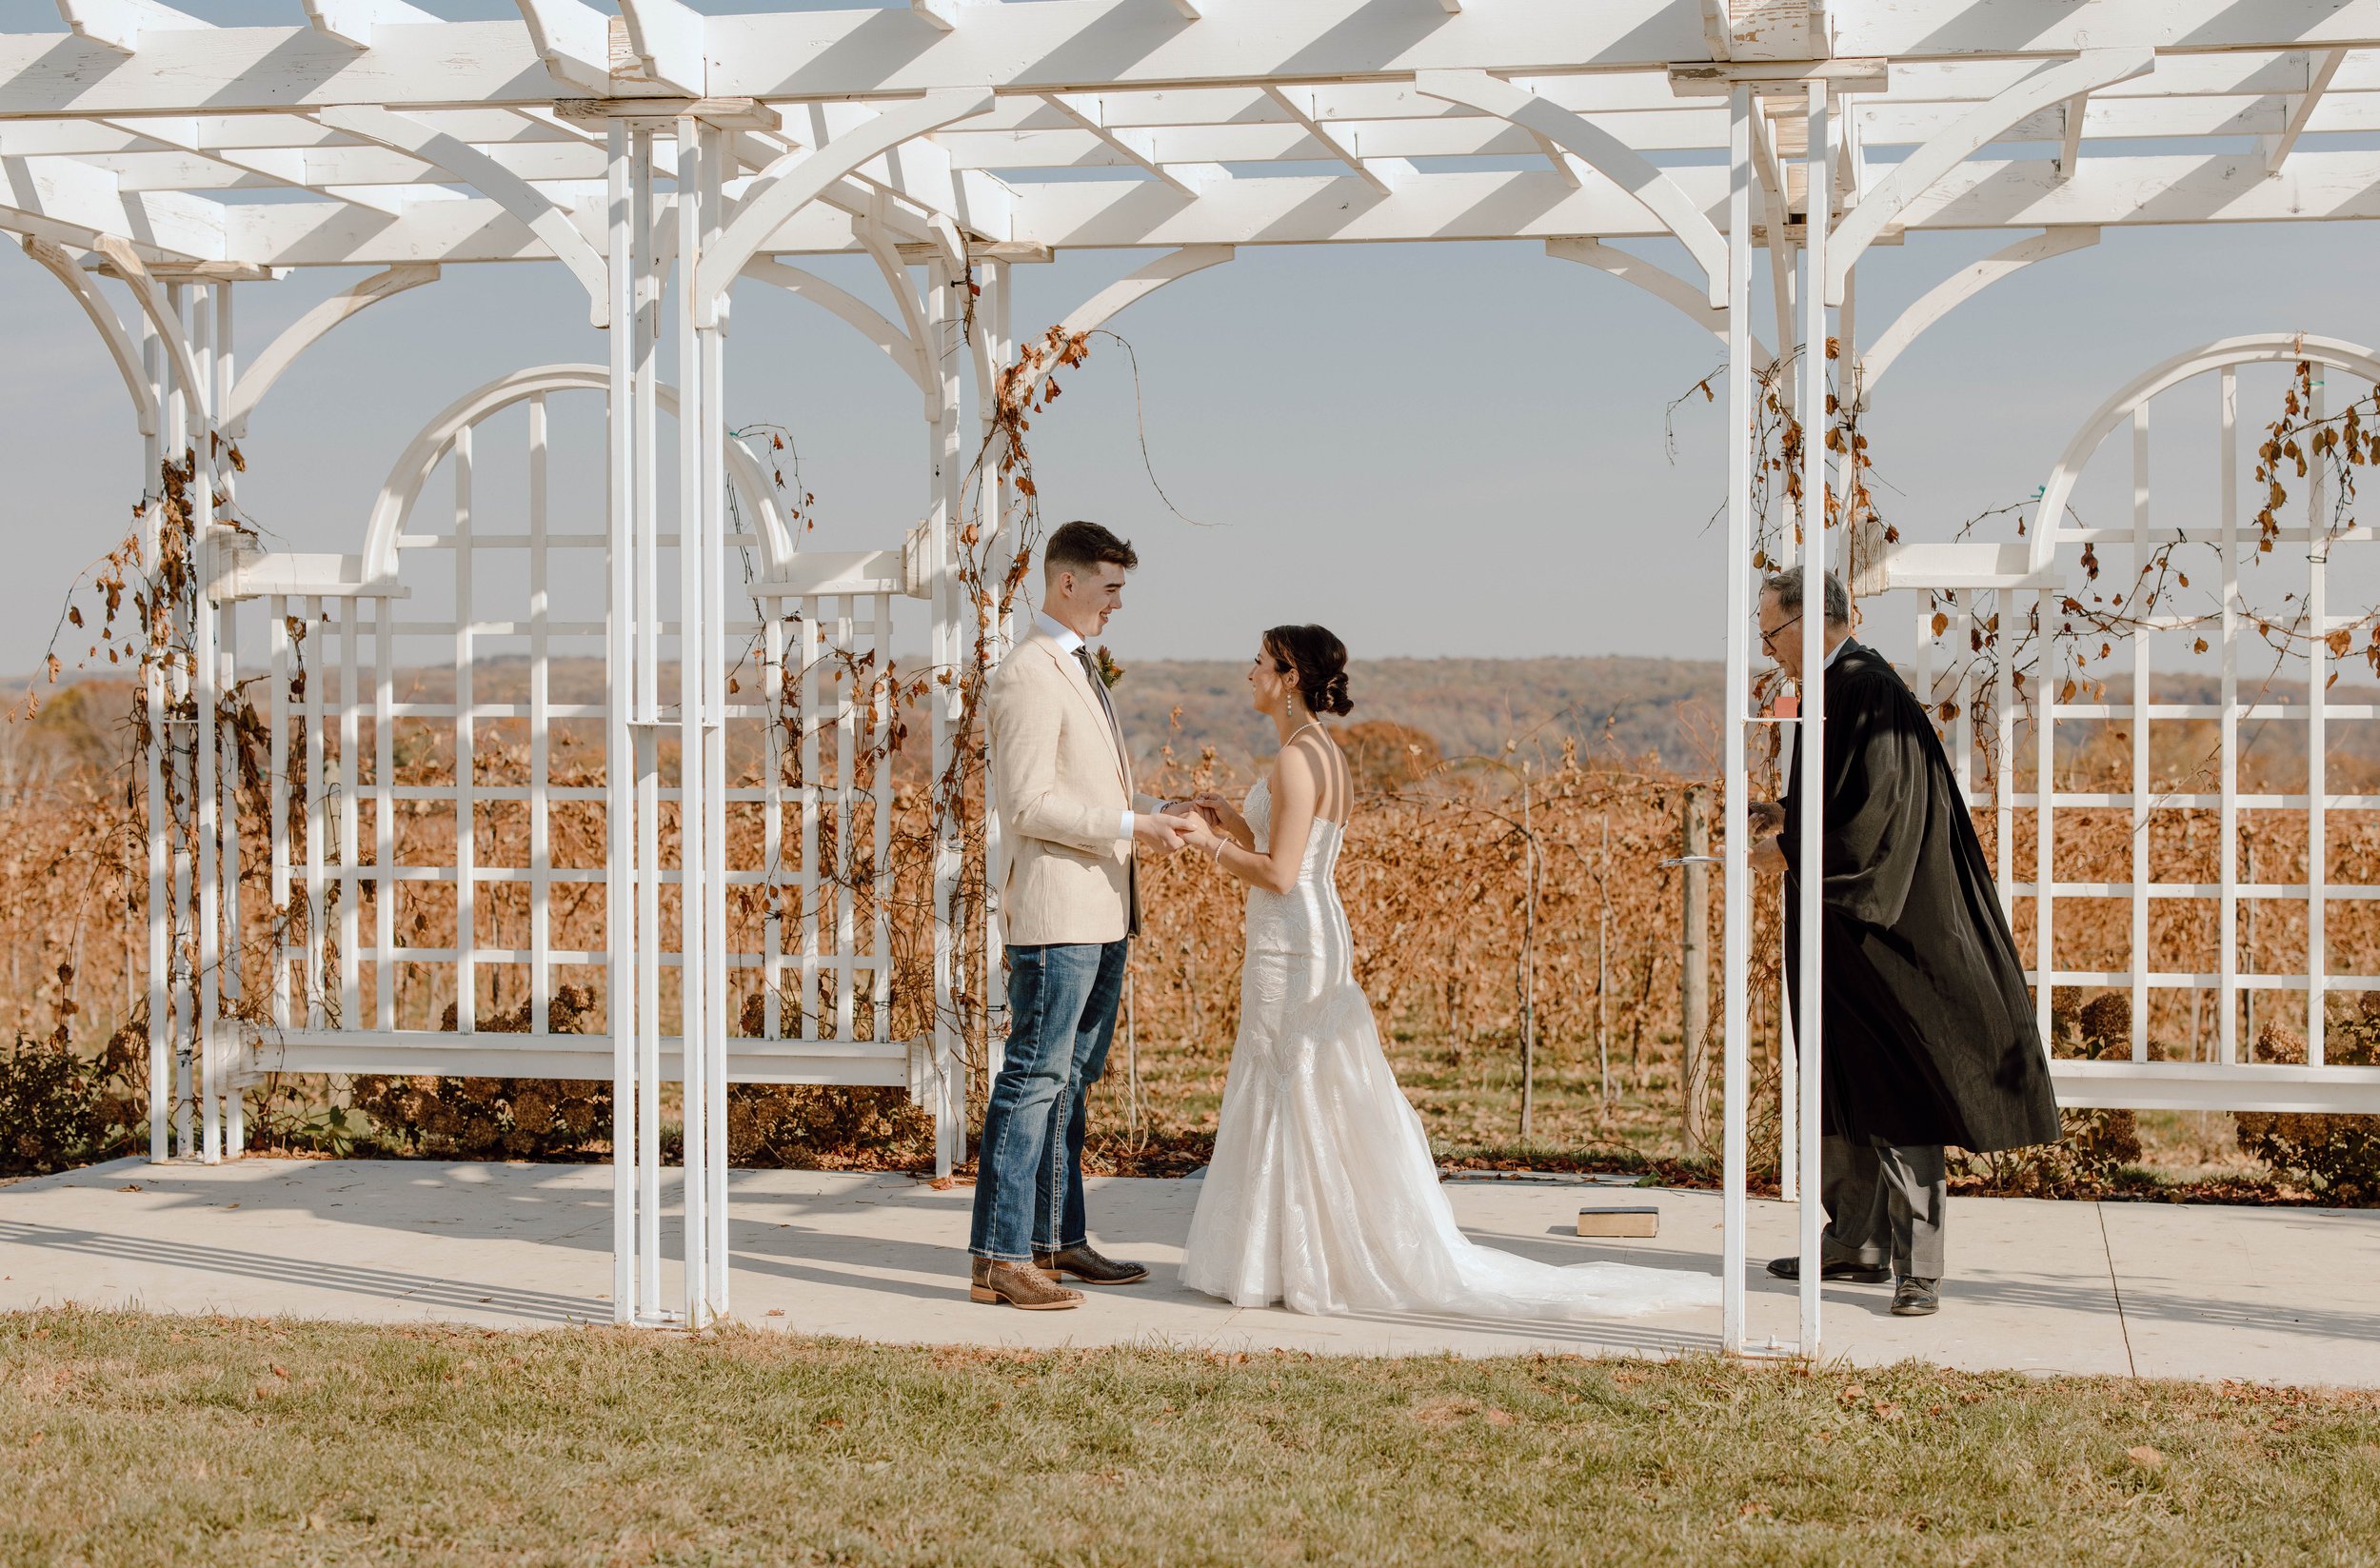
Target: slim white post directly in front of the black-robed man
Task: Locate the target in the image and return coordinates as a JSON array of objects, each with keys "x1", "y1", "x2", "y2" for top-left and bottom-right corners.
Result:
[{"x1": 1795, "y1": 81, "x2": 1833, "y2": 1361}]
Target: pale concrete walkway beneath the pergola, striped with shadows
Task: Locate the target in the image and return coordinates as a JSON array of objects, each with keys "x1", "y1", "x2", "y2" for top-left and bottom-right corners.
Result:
[{"x1": 0, "y1": 1159, "x2": 2380, "y2": 1387}]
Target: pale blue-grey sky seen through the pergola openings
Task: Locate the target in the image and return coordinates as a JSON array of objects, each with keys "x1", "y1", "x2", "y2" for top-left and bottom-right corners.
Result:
[{"x1": 0, "y1": 0, "x2": 2380, "y2": 668}]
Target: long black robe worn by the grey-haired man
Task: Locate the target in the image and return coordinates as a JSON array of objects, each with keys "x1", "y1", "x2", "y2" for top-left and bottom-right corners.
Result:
[{"x1": 1783, "y1": 643, "x2": 2059, "y2": 1154}]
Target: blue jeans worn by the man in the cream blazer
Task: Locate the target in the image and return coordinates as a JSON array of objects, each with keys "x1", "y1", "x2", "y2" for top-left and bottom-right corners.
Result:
[{"x1": 966, "y1": 943, "x2": 1131, "y2": 1263}]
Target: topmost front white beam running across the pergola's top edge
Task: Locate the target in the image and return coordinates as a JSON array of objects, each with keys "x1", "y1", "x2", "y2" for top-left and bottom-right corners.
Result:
[{"x1": 23, "y1": 0, "x2": 2380, "y2": 116}]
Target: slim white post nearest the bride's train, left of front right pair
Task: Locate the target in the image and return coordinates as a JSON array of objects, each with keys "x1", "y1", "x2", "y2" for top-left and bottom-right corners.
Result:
[{"x1": 1718, "y1": 86, "x2": 1755, "y2": 1354}]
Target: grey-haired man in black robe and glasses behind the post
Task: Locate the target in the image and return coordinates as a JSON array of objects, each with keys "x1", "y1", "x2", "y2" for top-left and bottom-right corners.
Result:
[{"x1": 1752, "y1": 568, "x2": 2059, "y2": 1319}]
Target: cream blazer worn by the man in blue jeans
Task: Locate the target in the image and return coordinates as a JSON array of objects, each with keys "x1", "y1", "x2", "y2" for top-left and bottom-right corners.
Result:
[{"x1": 985, "y1": 625, "x2": 1157, "y2": 947}]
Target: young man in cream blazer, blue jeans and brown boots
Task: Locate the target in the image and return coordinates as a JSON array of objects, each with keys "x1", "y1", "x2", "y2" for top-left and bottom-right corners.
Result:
[{"x1": 966, "y1": 524, "x2": 1190, "y2": 1311}]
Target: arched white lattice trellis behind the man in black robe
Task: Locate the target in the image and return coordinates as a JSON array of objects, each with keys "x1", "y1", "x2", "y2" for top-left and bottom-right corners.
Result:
[{"x1": 1890, "y1": 333, "x2": 2380, "y2": 1111}]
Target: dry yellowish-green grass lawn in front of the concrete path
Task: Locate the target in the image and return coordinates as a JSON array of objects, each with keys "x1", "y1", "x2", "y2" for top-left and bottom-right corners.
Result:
[{"x1": 0, "y1": 1311, "x2": 2380, "y2": 1568}]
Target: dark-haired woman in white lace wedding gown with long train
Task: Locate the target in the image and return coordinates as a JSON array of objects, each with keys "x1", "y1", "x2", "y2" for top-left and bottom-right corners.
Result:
[{"x1": 1183, "y1": 625, "x2": 1718, "y2": 1319}]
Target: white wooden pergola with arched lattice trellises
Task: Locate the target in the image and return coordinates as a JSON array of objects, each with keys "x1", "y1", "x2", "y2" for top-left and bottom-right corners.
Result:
[{"x1": 13, "y1": 0, "x2": 2380, "y2": 1354}]
